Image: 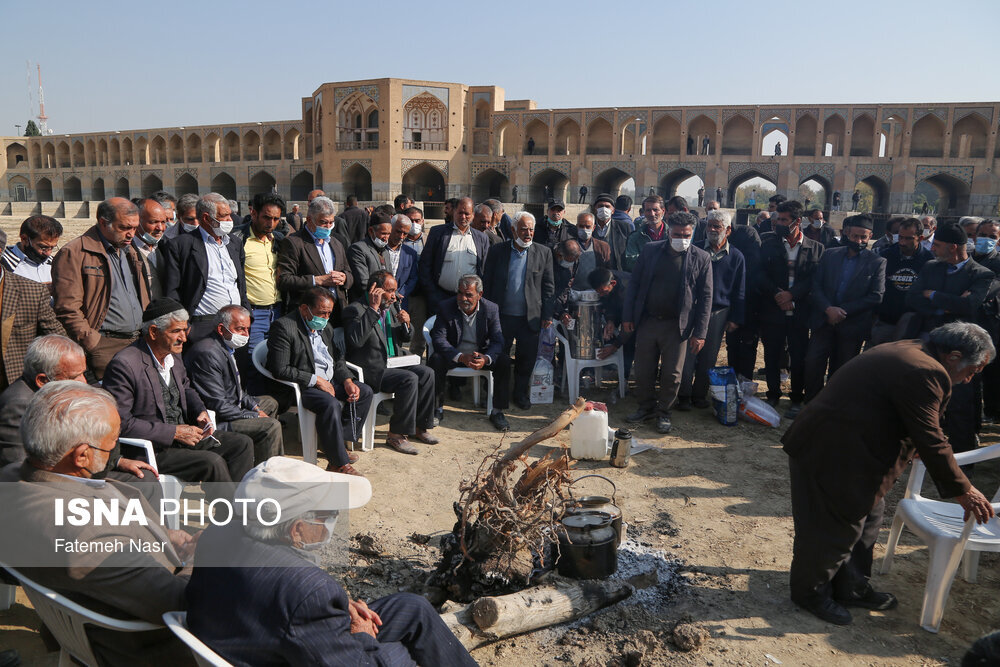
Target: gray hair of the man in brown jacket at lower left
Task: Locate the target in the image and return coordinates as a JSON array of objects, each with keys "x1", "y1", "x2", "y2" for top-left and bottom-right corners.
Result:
[{"x1": 21, "y1": 380, "x2": 117, "y2": 468}]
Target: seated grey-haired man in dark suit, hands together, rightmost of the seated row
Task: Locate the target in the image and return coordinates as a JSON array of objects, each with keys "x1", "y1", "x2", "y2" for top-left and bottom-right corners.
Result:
[{"x1": 427, "y1": 273, "x2": 510, "y2": 431}]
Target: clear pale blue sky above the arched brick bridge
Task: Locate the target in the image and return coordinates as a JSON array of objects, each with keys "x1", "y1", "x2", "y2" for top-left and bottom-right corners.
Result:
[{"x1": 0, "y1": 0, "x2": 1000, "y2": 135}]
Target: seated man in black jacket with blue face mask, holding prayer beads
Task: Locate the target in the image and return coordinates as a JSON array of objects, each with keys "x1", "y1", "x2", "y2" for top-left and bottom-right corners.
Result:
[{"x1": 267, "y1": 286, "x2": 372, "y2": 475}]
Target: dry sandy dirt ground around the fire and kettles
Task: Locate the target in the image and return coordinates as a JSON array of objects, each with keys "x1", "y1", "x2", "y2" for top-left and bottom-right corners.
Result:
[{"x1": 0, "y1": 370, "x2": 1000, "y2": 667}]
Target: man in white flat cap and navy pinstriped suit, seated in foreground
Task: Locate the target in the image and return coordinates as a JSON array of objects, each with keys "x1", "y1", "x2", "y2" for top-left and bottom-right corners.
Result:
[{"x1": 187, "y1": 456, "x2": 476, "y2": 665}]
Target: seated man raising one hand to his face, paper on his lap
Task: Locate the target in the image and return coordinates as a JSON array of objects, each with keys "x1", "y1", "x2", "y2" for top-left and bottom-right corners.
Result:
[{"x1": 344, "y1": 271, "x2": 438, "y2": 454}]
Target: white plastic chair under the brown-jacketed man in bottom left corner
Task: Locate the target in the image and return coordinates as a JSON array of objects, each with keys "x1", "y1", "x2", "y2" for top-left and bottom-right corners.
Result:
[{"x1": 4, "y1": 566, "x2": 163, "y2": 667}]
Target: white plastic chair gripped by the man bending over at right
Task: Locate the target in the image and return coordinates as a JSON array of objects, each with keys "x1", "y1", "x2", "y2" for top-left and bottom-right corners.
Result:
[{"x1": 881, "y1": 444, "x2": 1000, "y2": 632}]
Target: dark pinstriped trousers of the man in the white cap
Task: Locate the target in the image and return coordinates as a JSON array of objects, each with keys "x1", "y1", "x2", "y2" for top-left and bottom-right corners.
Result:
[{"x1": 368, "y1": 593, "x2": 477, "y2": 667}]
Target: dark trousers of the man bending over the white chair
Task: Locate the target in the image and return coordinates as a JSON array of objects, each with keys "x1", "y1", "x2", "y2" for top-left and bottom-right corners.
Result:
[{"x1": 788, "y1": 459, "x2": 885, "y2": 606}]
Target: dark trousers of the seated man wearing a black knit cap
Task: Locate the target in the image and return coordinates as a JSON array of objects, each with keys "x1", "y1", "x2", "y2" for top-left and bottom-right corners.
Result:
[{"x1": 156, "y1": 431, "x2": 253, "y2": 482}]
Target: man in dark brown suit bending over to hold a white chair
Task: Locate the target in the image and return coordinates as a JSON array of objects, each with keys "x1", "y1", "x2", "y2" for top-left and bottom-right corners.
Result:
[{"x1": 781, "y1": 322, "x2": 996, "y2": 625}]
